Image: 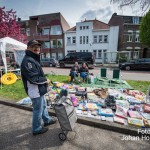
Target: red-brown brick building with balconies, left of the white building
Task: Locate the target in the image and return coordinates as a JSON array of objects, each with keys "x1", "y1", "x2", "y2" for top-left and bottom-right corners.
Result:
[{"x1": 18, "y1": 13, "x2": 70, "y2": 59}]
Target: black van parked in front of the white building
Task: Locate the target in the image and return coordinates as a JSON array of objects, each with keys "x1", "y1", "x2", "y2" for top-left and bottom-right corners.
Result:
[{"x1": 59, "y1": 52, "x2": 95, "y2": 68}]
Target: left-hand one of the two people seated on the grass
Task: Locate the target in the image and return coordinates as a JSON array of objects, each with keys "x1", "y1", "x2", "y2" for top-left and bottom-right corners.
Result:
[{"x1": 69, "y1": 62, "x2": 80, "y2": 82}]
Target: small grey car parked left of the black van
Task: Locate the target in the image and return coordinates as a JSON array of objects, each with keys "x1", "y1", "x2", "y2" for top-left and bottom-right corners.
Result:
[{"x1": 41, "y1": 58, "x2": 58, "y2": 67}]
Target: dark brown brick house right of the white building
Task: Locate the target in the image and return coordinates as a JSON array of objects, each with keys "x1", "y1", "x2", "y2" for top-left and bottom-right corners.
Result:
[{"x1": 108, "y1": 13, "x2": 150, "y2": 59}]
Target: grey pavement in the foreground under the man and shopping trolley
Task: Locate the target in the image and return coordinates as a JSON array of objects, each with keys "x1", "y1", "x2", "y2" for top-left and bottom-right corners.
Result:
[{"x1": 0, "y1": 105, "x2": 150, "y2": 150}]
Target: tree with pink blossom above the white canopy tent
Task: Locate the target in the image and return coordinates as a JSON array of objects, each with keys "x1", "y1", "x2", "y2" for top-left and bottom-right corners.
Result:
[{"x1": 0, "y1": 7, "x2": 27, "y2": 43}]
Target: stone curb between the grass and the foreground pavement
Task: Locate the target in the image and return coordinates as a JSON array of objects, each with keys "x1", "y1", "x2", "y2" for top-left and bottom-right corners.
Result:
[{"x1": 0, "y1": 100, "x2": 143, "y2": 136}]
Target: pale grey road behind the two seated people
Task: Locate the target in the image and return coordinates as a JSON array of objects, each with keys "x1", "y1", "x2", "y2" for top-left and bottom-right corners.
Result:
[{"x1": 43, "y1": 67, "x2": 150, "y2": 81}]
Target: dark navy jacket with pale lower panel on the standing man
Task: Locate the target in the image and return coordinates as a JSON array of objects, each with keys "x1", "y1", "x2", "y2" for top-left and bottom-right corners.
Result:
[{"x1": 21, "y1": 50, "x2": 48, "y2": 98}]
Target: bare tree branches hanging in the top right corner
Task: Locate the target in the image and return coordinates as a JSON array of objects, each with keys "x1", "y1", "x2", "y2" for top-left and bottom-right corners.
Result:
[{"x1": 110, "y1": 0, "x2": 150, "y2": 12}]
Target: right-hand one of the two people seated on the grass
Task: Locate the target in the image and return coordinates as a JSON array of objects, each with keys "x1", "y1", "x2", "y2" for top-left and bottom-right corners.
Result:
[{"x1": 80, "y1": 63, "x2": 89, "y2": 81}]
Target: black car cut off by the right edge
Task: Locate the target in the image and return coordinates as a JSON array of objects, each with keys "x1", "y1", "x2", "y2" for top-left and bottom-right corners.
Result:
[{"x1": 119, "y1": 58, "x2": 150, "y2": 70}]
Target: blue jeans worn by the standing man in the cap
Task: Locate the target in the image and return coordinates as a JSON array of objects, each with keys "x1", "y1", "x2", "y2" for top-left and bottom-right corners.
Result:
[{"x1": 31, "y1": 96, "x2": 51, "y2": 132}]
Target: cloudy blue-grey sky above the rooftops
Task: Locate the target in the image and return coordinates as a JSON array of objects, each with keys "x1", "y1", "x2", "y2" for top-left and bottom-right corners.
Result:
[{"x1": 0, "y1": 0, "x2": 142, "y2": 27}]
